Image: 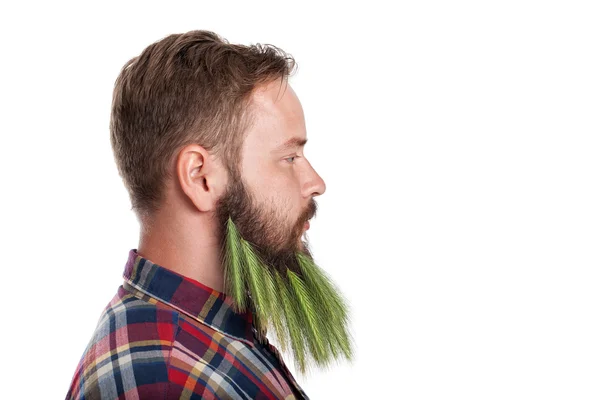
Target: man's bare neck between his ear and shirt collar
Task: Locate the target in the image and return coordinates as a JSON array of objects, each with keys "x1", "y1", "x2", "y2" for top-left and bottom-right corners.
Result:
[{"x1": 138, "y1": 209, "x2": 223, "y2": 292}]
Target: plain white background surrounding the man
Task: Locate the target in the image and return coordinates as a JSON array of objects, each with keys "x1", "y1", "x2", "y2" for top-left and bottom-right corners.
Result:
[{"x1": 0, "y1": 0, "x2": 600, "y2": 399}]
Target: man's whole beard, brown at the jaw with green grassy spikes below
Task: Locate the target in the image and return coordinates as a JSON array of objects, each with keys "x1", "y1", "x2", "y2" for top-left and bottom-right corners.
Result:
[{"x1": 216, "y1": 170, "x2": 353, "y2": 373}]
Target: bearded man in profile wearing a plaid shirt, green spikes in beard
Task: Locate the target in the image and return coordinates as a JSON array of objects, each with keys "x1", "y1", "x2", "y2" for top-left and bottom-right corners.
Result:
[{"x1": 67, "y1": 31, "x2": 352, "y2": 399}]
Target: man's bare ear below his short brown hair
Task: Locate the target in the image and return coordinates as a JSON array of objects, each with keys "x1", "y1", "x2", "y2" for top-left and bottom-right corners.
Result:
[{"x1": 175, "y1": 144, "x2": 227, "y2": 211}]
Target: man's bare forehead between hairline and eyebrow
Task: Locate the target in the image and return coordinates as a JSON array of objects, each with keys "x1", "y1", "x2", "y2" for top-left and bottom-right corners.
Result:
[{"x1": 245, "y1": 79, "x2": 306, "y2": 151}]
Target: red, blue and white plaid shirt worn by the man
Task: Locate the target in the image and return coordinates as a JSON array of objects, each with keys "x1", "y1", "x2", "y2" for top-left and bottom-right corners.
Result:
[{"x1": 66, "y1": 249, "x2": 308, "y2": 400}]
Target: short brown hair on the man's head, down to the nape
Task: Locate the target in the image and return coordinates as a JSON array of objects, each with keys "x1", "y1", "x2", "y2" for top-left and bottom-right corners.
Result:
[{"x1": 110, "y1": 30, "x2": 297, "y2": 225}]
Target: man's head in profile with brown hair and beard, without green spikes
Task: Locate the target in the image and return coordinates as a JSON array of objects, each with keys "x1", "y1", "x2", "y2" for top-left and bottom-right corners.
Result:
[{"x1": 110, "y1": 31, "x2": 325, "y2": 259}]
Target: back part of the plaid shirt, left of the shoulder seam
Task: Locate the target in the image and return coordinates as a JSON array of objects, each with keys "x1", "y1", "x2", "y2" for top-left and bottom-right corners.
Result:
[{"x1": 67, "y1": 287, "x2": 180, "y2": 399}]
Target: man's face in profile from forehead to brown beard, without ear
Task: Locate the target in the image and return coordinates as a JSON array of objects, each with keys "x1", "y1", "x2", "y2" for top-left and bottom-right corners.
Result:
[{"x1": 217, "y1": 81, "x2": 325, "y2": 271}]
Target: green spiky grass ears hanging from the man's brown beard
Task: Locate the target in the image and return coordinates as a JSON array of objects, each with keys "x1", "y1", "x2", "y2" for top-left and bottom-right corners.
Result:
[{"x1": 223, "y1": 217, "x2": 353, "y2": 374}]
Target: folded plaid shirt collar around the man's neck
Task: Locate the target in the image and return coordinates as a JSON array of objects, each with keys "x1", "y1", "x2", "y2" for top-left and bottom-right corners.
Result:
[{"x1": 123, "y1": 249, "x2": 254, "y2": 344}]
